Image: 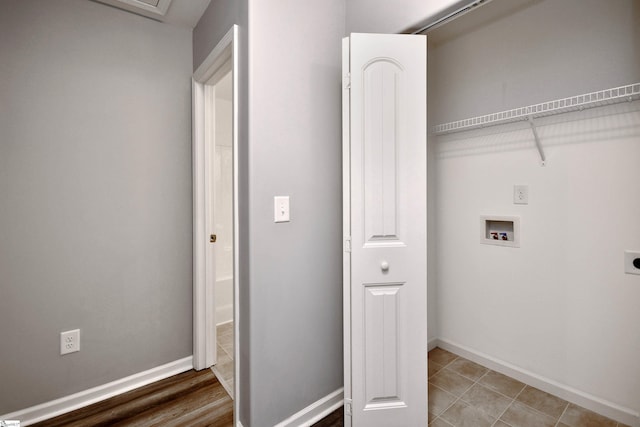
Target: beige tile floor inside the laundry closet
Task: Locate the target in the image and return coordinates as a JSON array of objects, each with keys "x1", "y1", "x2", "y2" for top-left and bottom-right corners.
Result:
[{"x1": 429, "y1": 348, "x2": 628, "y2": 427}]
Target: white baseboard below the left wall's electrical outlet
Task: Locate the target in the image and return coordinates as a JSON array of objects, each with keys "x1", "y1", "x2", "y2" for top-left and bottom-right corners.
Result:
[{"x1": 0, "y1": 356, "x2": 193, "y2": 426}]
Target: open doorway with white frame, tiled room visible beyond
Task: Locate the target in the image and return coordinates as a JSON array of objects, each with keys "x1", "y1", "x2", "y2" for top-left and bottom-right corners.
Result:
[{"x1": 193, "y1": 25, "x2": 239, "y2": 418}]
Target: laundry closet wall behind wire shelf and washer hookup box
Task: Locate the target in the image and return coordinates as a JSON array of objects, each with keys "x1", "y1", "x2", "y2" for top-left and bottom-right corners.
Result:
[{"x1": 429, "y1": 0, "x2": 640, "y2": 418}]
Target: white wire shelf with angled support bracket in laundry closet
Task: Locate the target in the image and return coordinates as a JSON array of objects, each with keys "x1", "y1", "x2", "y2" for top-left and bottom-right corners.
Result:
[{"x1": 433, "y1": 83, "x2": 640, "y2": 166}]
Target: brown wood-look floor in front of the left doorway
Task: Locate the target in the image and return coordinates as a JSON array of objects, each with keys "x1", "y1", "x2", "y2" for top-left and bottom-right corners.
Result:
[{"x1": 33, "y1": 369, "x2": 233, "y2": 427}]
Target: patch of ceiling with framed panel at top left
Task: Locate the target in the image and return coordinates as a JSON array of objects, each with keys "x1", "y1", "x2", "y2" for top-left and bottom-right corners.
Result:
[{"x1": 96, "y1": 0, "x2": 211, "y2": 29}]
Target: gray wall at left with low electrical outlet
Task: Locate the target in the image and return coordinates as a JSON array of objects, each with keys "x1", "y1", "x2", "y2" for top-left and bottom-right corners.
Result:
[{"x1": 0, "y1": 0, "x2": 192, "y2": 414}]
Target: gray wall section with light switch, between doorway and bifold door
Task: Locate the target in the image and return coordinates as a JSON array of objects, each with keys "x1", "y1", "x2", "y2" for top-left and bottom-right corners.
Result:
[{"x1": 249, "y1": 0, "x2": 345, "y2": 427}]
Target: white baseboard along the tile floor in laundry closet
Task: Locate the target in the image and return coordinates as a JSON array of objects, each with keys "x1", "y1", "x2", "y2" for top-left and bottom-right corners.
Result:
[{"x1": 436, "y1": 339, "x2": 640, "y2": 427}]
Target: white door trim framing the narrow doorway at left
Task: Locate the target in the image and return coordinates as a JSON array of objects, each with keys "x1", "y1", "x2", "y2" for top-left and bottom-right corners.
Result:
[{"x1": 192, "y1": 25, "x2": 240, "y2": 413}]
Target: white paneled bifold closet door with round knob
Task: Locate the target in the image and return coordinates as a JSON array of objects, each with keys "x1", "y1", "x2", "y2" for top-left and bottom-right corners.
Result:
[{"x1": 343, "y1": 34, "x2": 428, "y2": 427}]
